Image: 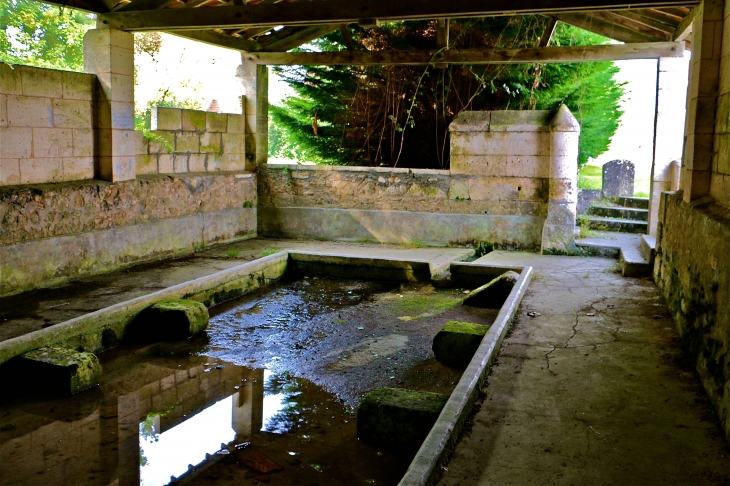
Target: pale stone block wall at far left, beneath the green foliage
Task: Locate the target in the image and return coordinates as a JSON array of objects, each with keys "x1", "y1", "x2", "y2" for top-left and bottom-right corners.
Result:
[{"x1": 0, "y1": 63, "x2": 96, "y2": 186}]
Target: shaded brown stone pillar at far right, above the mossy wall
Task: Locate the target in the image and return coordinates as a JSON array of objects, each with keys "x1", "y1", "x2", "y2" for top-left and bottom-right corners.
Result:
[{"x1": 682, "y1": 0, "x2": 725, "y2": 202}]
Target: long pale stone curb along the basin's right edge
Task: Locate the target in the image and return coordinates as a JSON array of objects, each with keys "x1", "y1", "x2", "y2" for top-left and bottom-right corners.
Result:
[{"x1": 398, "y1": 263, "x2": 532, "y2": 486}]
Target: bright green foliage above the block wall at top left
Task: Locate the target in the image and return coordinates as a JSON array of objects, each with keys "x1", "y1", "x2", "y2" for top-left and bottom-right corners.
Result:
[{"x1": 0, "y1": 0, "x2": 95, "y2": 71}]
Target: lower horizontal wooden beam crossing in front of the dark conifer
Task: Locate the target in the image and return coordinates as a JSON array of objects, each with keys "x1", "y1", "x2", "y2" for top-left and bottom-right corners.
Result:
[{"x1": 242, "y1": 42, "x2": 684, "y2": 66}]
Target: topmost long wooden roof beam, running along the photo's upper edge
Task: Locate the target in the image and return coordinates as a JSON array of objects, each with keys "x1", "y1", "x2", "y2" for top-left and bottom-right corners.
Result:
[{"x1": 95, "y1": 0, "x2": 699, "y2": 31}]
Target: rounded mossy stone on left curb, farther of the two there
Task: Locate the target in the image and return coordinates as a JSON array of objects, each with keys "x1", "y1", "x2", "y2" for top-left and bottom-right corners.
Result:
[{"x1": 127, "y1": 299, "x2": 209, "y2": 342}]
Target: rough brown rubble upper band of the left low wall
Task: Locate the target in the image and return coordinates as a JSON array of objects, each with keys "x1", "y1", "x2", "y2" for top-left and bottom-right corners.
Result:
[{"x1": 0, "y1": 172, "x2": 256, "y2": 245}]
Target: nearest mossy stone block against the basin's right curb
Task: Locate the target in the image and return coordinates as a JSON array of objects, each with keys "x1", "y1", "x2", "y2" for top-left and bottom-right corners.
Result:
[{"x1": 357, "y1": 388, "x2": 449, "y2": 449}]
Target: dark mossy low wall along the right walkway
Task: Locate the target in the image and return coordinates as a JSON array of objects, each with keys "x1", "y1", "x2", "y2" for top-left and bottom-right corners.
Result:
[{"x1": 654, "y1": 192, "x2": 730, "y2": 439}]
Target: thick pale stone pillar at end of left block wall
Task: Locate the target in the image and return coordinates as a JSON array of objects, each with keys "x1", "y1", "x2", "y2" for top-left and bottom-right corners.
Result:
[{"x1": 84, "y1": 29, "x2": 137, "y2": 181}]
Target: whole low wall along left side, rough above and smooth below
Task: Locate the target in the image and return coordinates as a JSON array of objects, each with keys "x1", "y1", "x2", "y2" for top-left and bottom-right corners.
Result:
[{"x1": 0, "y1": 173, "x2": 256, "y2": 295}]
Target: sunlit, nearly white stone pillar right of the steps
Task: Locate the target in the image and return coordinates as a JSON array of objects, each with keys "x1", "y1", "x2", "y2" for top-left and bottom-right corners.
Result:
[{"x1": 649, "y1": 57, "x2": 688, "y2": 236}]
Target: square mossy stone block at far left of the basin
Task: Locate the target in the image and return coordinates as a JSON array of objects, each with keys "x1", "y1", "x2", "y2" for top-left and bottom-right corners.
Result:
[{"x1": 19, "y1": 346, "x2": 101, "y2": 395}]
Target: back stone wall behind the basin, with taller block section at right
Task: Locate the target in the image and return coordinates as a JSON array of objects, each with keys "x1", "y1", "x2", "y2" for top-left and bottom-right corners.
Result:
[{"x1": 258, "y1": 111, "x2": 578, "y2": 250}]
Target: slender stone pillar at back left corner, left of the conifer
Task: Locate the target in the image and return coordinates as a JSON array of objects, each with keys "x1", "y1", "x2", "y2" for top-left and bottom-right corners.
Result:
[{"x1": 236, "y1": 59, "x2": 269, "y2": 170}]
